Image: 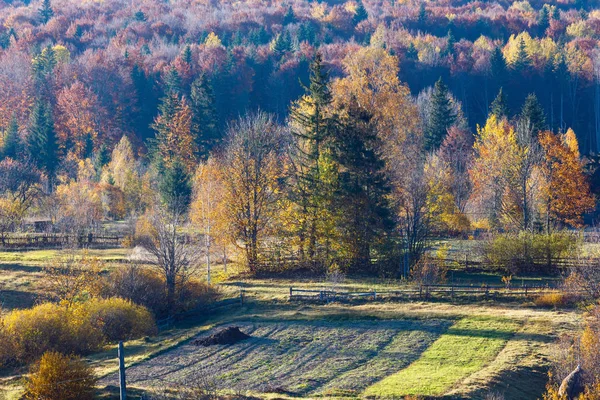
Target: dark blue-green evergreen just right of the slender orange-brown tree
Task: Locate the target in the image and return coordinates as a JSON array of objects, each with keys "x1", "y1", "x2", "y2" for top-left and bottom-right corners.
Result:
[{"x1": 190, "y1": 75, "x2": 220, "y2": 159}]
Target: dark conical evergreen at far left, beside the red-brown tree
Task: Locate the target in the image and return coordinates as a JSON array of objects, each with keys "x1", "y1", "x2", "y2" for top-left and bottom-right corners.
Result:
[{"x1": 26, "y1": 100, "x2": 58, "y2": 183}]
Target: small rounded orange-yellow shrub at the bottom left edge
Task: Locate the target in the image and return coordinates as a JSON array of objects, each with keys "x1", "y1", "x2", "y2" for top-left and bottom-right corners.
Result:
[{"x1": 23, "y1": 351, "x2": 96, "y2": 400}]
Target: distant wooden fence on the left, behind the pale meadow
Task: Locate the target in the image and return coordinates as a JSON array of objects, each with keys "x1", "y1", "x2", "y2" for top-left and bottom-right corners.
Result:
[{"x1": 0, "y1": 233, "x2": 123, "y2": 250}]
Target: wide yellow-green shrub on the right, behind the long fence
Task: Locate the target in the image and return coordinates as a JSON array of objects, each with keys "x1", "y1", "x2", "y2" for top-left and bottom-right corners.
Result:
[{"x1": 484, "y1": 232, "x2": 579, "y2": 275}]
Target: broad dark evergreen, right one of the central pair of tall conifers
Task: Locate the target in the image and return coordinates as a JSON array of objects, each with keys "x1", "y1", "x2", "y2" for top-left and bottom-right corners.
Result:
[{"x1": 332, "y1": 101, "x2": 394, "y2": 271}]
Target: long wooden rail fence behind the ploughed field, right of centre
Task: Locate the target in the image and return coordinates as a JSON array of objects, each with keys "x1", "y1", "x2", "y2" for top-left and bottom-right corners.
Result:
[{"x1": 289, "y1": 285, "x2": 557, "y2": 302}]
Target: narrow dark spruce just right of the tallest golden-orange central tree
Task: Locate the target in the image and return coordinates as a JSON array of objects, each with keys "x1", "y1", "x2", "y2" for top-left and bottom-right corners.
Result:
[{"x1": 425, "y1": 78, "x2": 456, "y2": 151}]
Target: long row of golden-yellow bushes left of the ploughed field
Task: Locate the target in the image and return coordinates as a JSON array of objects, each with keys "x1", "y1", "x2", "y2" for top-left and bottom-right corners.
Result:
[{"x1": 0, "y1": 299, "x2": 156, "y2": 365}]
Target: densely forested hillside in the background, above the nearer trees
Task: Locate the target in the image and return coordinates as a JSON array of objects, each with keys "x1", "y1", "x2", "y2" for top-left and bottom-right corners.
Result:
[{"x1": 0, "y1": 0, "x2": 600, "y2": 153}]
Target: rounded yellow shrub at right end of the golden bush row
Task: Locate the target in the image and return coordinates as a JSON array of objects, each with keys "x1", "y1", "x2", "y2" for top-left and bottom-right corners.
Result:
[{"x1": 86, "y1": 298, "x2": 156, "y2": 342}]
